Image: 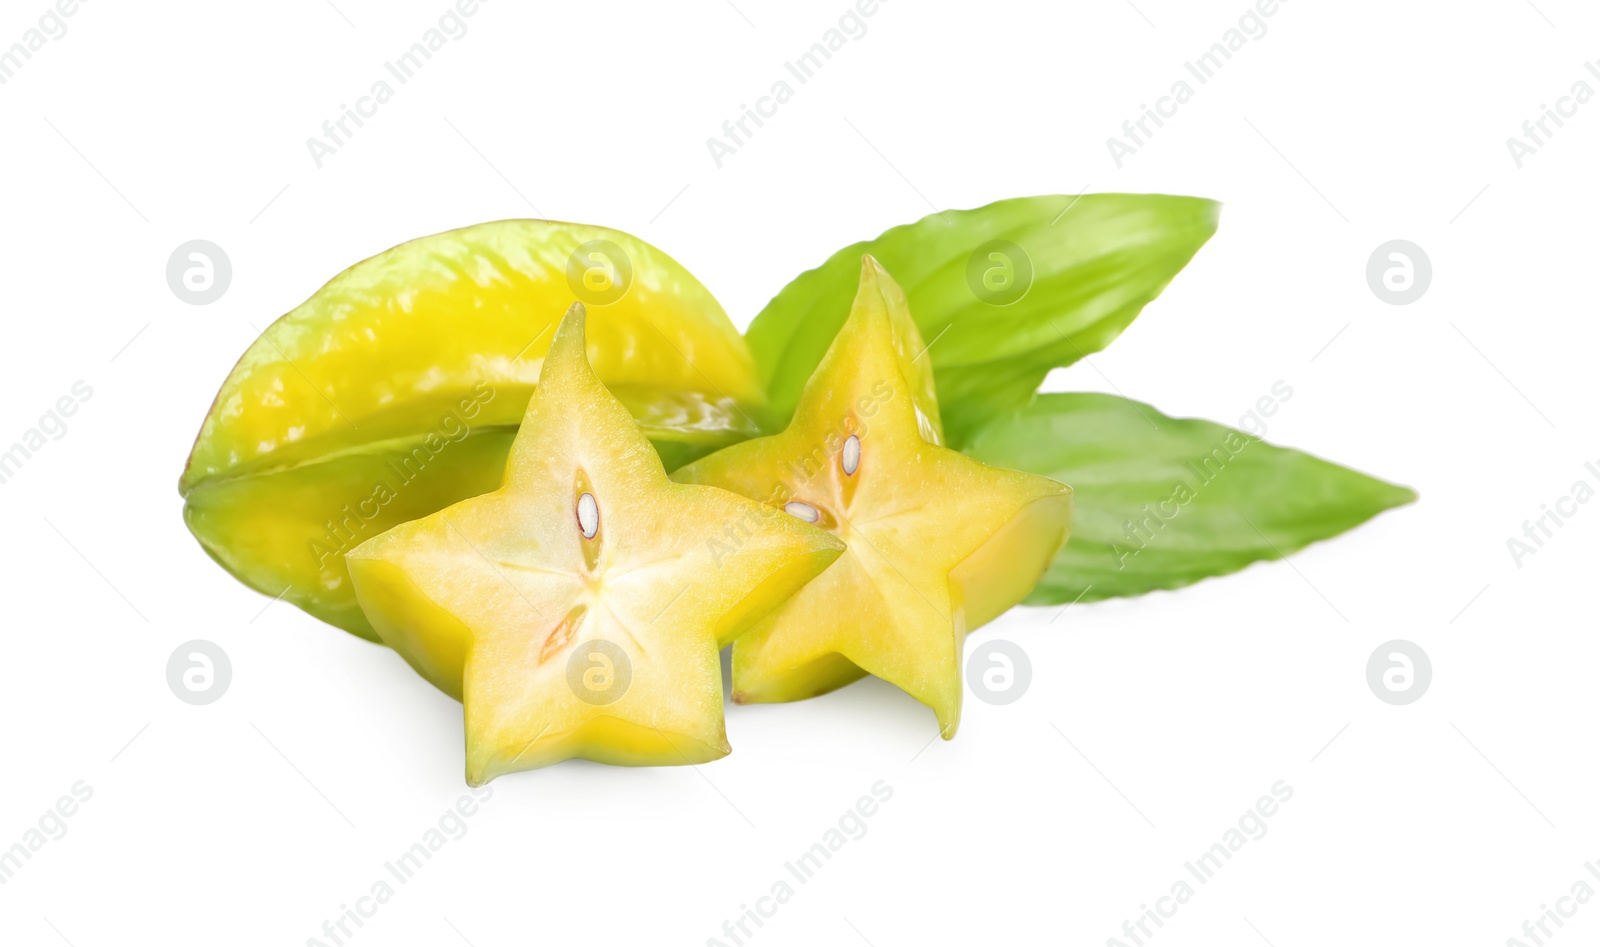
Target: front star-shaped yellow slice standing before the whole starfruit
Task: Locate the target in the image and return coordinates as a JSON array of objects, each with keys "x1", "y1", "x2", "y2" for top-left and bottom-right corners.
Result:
[{"x1": 347, "y1": 304, "x2": 843, "y2": 785}]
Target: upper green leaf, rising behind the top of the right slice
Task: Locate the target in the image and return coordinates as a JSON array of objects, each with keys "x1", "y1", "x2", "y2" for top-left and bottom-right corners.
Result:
[{"x1": 747, "y1": 194, "x2": 1219, "y2": 446}]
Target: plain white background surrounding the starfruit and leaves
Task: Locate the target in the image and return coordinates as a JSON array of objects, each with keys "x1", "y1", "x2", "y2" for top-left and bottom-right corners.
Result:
[{"x1": 0, "y1": 0, "x2": 1600, "y2": 947}]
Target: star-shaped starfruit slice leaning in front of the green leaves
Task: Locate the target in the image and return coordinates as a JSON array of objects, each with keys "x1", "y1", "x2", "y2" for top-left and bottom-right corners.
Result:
[{"x1": 674, "y1": 256, "x2": 1072, "y2": 739}]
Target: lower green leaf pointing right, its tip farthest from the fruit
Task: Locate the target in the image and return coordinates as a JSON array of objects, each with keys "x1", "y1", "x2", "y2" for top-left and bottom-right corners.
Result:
[{"x1": 966, "y1": 393, "x2": 1416, "y2": 605}]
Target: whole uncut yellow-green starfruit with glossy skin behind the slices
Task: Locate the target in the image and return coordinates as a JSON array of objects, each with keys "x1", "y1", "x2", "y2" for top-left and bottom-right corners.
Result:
[{"x1": 179, "y1": 221, "x2": 763, "y2": 640}]
